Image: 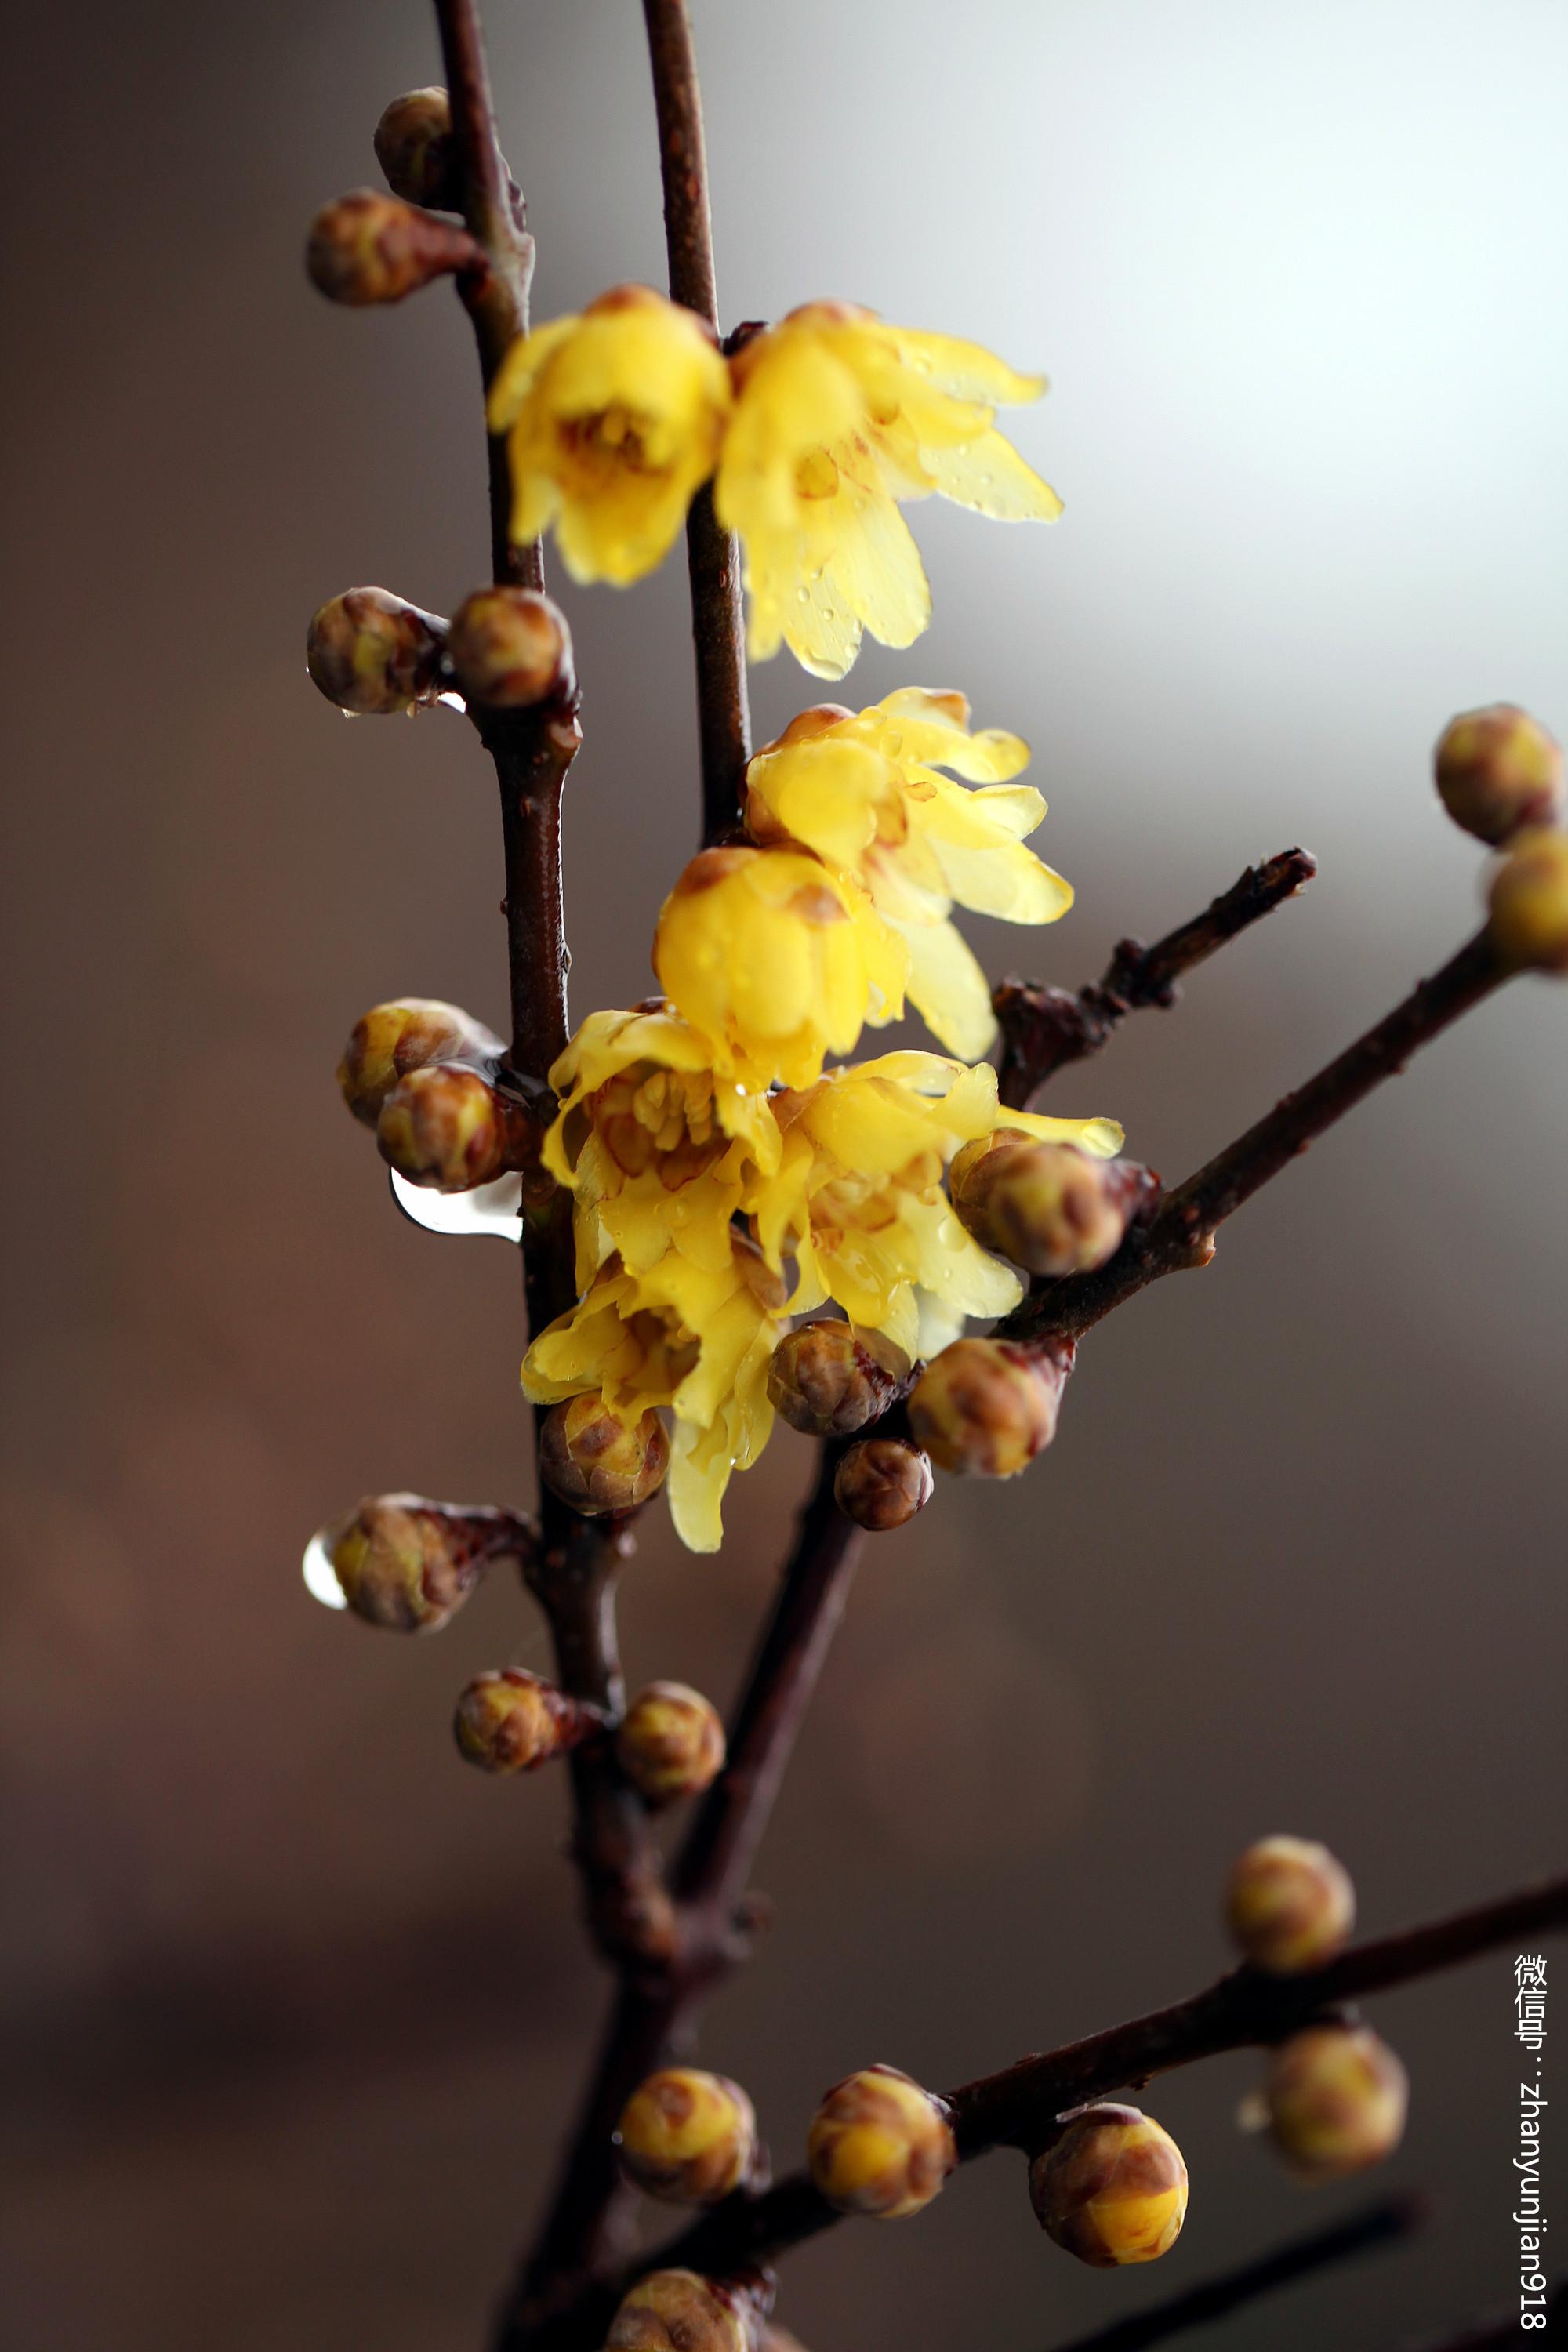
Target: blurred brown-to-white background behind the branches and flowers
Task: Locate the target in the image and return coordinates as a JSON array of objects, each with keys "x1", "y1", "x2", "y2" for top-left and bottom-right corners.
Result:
[{"x1": 0, "y1": 0, "x2": 1568, "y2": 2352}]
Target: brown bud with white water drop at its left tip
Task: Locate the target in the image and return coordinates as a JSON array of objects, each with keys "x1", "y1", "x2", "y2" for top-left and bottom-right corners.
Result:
[{"x1": 306, "y1": 1494, "x2": 532, "y2": 1632}]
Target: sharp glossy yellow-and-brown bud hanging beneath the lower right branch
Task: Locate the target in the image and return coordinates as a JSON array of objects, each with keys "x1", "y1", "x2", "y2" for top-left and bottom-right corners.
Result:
[{"x1": 1029, "y1": 2100, "x2": 1187, "y2": 2270}]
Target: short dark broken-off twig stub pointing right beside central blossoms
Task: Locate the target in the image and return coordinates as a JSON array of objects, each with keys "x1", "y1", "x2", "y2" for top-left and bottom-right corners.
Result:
[{"x1": 994, "y1": 849, "x2": 1316, "y2": 1110}]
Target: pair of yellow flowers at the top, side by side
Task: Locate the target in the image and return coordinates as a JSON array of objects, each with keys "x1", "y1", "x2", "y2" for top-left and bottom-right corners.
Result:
[{"x1": 489, "y1": 287, "x2": 1060, "y2": 677}]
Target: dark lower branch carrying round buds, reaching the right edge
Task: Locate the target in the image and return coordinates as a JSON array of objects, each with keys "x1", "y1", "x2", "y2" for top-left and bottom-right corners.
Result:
[{"x1": 580, "y1": 1877, "x2": 1568, "y2": 2324}]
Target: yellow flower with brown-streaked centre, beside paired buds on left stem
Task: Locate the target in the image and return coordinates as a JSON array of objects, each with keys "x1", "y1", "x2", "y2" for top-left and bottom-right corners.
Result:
[{"x1": 543, "y1": 997, "x2": 781, "y2": 1289}]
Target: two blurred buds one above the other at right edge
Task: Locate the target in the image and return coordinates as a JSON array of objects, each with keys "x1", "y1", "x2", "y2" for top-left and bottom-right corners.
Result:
[{"x1": 1434, "y1": 703, "x2": 1568, "y2": 974}]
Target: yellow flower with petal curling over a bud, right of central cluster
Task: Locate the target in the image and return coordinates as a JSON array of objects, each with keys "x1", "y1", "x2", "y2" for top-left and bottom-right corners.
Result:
[{"x1": 755, "y1": 1054, "x2": 1121, "y2": 1359}]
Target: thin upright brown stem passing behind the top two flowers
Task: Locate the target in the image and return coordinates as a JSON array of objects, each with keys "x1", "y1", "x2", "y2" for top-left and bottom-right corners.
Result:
[{"x1": 642, "y1": 0, "x2": 750, "y2": 842}]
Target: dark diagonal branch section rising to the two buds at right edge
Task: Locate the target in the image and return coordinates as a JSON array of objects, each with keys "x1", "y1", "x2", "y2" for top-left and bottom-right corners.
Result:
[{"x1": 996, "y1": 931, "x2": 1509, "y2": 1341}]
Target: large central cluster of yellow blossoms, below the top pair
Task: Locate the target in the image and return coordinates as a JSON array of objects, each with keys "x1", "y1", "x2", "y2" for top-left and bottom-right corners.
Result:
[{"x1": 522, "y1": 689, "x2": 1121, "y2": 1550}]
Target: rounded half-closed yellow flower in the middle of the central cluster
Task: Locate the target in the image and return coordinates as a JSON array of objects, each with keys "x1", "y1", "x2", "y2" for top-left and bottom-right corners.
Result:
[{"x1": 654, "y1": 849, "x2": 907, "y2": 1091}]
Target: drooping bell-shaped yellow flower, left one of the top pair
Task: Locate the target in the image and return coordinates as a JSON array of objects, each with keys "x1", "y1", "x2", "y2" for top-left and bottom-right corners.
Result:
[{"x1": 489, "y1": 287, "x2": 731, "y2": 588}]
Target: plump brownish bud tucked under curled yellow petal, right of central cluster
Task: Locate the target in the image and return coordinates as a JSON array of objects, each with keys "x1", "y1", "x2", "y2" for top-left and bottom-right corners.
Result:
[{"x1": 947, "y1": 1127, "x2": 1126, "y2": 1275}]
